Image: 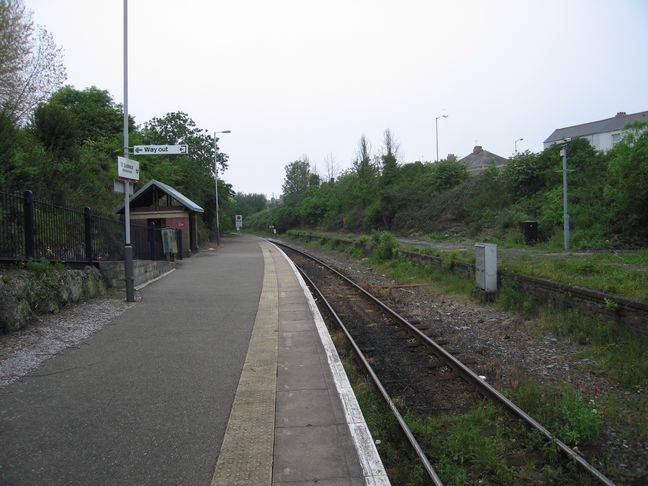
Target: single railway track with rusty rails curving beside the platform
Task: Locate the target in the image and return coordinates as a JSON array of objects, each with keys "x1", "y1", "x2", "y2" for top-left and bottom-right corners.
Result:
[{"x1": 272, "y1": 241, "x2": 614, "y2": 485}]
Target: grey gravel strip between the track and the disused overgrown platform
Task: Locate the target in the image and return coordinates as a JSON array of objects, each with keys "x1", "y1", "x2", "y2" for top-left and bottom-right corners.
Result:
[{"x1": 282, "y1": 242, "x2": 648, "y2": 484}]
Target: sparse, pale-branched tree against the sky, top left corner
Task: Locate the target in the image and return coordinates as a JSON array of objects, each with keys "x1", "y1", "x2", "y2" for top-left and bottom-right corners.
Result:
[{"x1": 0, "y1": 0, "x2": 66, "y2": 124}]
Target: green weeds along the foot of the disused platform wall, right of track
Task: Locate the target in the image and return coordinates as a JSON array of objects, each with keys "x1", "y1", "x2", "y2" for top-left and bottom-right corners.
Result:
[{"x1": 288, "y1": 235, "x2": 648, "y2": 484}]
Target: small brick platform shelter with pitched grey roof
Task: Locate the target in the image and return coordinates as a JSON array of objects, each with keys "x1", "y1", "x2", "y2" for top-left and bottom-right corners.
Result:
[{"x1": 115, "y1": 179, "x2": 204, "y2": 255}]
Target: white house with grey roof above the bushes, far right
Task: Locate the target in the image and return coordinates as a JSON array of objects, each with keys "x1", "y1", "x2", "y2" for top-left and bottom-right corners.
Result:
[{"x1": 544, "y1": 111, "x2": 648, "y2": 152}]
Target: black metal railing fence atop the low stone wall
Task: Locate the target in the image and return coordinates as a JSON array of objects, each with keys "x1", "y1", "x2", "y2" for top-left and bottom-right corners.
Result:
[{"x1": 0, "y1": 191, "x2": 171, "y2": 263}]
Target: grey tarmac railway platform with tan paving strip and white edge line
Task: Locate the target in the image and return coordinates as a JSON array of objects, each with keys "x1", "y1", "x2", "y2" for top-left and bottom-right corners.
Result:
[{"x1": 0, "y1": 235, "x2": 389, "y2": 486}]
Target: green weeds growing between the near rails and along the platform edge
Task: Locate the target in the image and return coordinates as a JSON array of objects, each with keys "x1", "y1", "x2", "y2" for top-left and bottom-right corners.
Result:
[{"x1": 332, "y1": 331, "x2": 593, "y2": 486}]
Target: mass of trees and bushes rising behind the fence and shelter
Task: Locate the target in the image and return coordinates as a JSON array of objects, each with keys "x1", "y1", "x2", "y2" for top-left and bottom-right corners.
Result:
[{"x1": 0, "y1": 0, "x2": 267, "y2": 238}]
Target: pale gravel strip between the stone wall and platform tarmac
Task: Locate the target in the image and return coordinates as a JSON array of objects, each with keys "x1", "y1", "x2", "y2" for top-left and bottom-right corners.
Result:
[{"x1": 0, "y1": 294, "x2": 134, "y2": 387}]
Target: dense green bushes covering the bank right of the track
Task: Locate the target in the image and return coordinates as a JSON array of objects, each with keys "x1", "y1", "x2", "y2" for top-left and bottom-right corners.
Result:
[{"x1": 248, "y1": 123, "x2": 648, "y2": 248}]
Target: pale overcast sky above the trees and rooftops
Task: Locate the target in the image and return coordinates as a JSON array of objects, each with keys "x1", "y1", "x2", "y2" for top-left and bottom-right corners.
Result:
[{"x1": 25, "y1": 0, "x2": 648, "y2": 196}]
